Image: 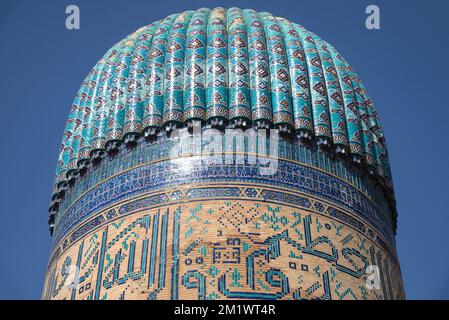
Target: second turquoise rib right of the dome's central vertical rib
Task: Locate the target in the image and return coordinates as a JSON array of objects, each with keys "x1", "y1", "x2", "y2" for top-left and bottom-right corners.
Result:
[{"x1": 243, "y1": 9, "x2": 273, "y2": 128}]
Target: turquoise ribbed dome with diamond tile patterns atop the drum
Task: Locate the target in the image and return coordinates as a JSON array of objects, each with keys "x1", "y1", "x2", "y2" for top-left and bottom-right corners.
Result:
[{"x1": 54, "y1": 8, "x2": 391, "y2": 222}]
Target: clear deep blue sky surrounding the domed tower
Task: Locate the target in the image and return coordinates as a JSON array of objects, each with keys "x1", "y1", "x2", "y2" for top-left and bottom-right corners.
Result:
[{"x1": 0, "y1": 0, "x2": 449, "y2": 299}]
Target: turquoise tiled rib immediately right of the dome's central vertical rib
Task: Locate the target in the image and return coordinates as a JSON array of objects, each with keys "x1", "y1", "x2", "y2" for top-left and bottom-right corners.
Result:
[{"x1": 227, "y1": 8, "x2": 251, "y2": 128}]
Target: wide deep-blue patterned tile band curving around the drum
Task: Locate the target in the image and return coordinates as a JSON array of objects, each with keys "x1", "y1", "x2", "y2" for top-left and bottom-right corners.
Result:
[{"x1": 53, "y1": 156, "x2": 395, "y2": 251}]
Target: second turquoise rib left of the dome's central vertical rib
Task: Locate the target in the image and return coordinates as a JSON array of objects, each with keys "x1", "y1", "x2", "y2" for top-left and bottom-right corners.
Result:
[{"x1": 163, "y1": 11, "x2": 193, "y2": 131}]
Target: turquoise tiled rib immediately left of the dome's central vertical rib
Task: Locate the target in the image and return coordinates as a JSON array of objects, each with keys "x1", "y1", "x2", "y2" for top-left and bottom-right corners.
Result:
[{"x1": 183, "y1": 9, "x2": 210, "y2": 127}]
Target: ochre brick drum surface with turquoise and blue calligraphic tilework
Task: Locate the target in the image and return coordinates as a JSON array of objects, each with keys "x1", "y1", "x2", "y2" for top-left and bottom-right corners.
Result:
[{"x1": 43, "y1": 199, "x2": 403, "y2": 299}]
